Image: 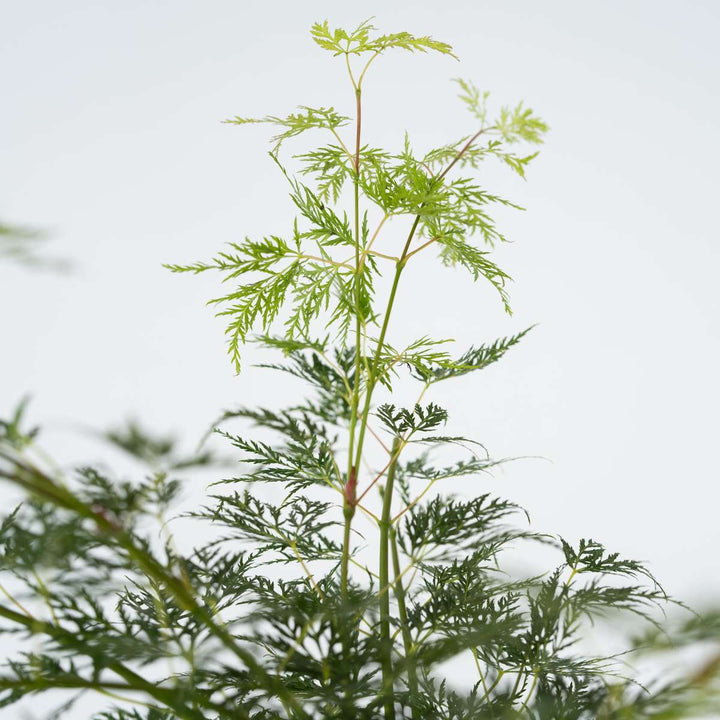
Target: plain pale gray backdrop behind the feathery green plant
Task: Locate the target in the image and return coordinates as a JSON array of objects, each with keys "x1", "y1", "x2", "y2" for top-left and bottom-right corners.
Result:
[{"x1": 0, "y1": 0, "x2": 720, "y2": 716}]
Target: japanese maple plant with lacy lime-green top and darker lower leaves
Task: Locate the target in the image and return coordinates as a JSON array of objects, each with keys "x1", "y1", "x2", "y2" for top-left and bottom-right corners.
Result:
[{"x1": 0, "y1": 22, "x2": 716, "y2": 720}]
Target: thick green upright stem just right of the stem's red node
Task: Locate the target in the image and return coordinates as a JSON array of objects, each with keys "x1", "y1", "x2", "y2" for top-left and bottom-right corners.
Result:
[{"x1": 380, "y1": 437, "x2": 401, "y2": 720}]
